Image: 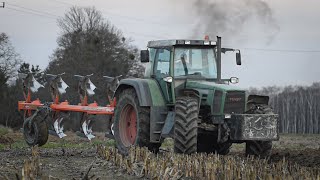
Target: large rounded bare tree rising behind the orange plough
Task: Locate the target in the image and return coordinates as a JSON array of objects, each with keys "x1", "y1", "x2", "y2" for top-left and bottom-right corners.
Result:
[{"x1": 46, "y1": 7, "x2": 140, "y2": 131}]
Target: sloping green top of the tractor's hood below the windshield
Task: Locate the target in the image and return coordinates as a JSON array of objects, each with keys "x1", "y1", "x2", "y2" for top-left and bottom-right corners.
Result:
[{"x1": 186, "y1": 80, "x2": 244, "y2": 91}]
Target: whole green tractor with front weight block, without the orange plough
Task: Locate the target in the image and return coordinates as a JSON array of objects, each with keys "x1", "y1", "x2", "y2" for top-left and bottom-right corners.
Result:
[{"x1": 112, "y1": 37, "x2": 279, "y2": 158}]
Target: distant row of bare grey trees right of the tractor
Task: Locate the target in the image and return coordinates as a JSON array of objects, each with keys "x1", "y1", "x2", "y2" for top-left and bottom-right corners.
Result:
[{"x1": 249, "y1": 82, "x2": 320, "y2": 134}]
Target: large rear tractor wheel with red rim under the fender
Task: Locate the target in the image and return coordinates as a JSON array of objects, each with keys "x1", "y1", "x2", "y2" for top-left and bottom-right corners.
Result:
[{"x1": 114, "y1": 89, "x2": 161, "y2": 155}]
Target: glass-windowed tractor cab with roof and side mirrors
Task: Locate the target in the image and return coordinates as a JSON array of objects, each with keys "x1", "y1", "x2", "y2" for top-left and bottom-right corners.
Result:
[{"x1": 141, "y1": 36, "x2": 241, "y2": 104}]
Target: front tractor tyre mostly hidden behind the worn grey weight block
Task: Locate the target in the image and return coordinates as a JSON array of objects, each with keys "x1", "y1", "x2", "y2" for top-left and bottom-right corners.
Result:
[{"x1": 246, "y1": 104, "x2": 274, "y2": 158}]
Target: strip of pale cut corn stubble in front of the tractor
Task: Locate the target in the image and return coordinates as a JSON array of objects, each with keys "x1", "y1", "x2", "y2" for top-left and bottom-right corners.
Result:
[{"x1": 97, "y1": 145, "x2": 320, "y2": 180}]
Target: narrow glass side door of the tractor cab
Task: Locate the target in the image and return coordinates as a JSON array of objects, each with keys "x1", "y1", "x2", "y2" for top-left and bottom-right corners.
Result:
[{"x1": 153, "y1": 48, "x2": 174, "y2": 104}]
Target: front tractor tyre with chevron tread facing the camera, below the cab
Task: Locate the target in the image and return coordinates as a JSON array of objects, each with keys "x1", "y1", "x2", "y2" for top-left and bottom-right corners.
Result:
[{"x1": 174, "y1": 97, "x2": 198, "y2": 154}]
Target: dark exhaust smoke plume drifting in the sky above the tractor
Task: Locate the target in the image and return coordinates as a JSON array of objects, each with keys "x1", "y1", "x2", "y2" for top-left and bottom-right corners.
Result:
[{"x1": 193, "y1": 0, "x2": 279, "y2": 43}]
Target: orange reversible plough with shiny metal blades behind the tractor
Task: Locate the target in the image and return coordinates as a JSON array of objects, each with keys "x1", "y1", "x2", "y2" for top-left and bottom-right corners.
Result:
[{"x1": 18, "y1": 73, "x2": 121, "y2": 146}]
